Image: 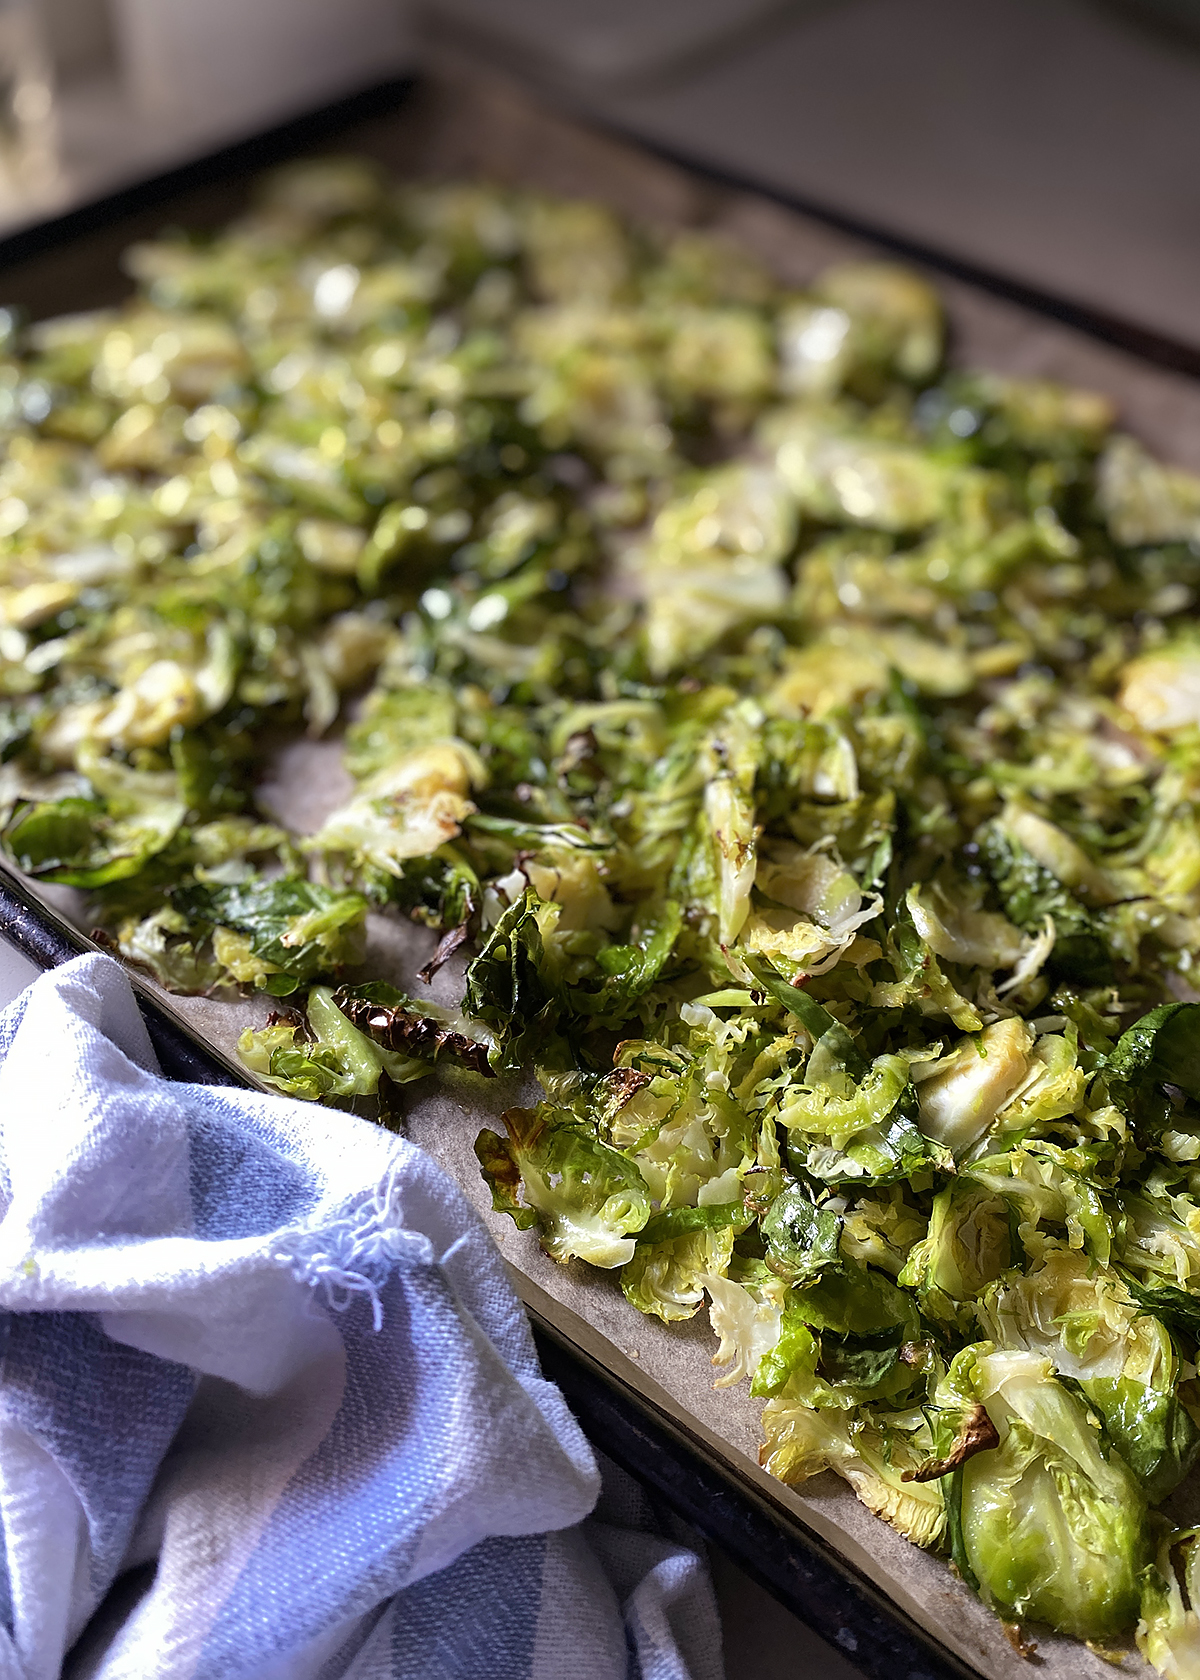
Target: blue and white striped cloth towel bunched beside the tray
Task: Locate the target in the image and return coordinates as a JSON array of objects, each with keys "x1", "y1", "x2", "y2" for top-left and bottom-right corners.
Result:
[{"x1": 0, "y1": 956, "x2": 721, "y2": 1680}]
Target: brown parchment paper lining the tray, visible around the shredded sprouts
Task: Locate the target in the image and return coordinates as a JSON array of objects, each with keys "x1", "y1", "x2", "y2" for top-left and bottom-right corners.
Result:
[{"x1": 14, "y1": 66, "x2": 1200, "y2": 1680}]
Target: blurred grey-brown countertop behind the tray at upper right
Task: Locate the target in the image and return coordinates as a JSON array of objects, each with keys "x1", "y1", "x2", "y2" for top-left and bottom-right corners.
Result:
[{"x1": 427, "y1": 0, "x2": 1200, "y2": 346}]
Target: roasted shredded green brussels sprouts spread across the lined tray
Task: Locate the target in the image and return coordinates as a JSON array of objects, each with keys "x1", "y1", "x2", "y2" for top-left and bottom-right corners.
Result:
[{"x1": 0, "y1": 160, "x2": 1200, "y2": 1653}]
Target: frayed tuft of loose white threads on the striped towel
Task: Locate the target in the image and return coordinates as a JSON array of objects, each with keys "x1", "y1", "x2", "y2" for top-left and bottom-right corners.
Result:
[{"x1": 274, "y1": 1161, "x2": 433, "y2": 1331}]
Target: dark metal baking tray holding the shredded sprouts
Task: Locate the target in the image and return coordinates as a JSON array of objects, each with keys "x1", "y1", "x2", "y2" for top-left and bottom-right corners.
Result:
[{"x1": 0, "y1": 62, "x2": 1200, "y2": 1680}]
